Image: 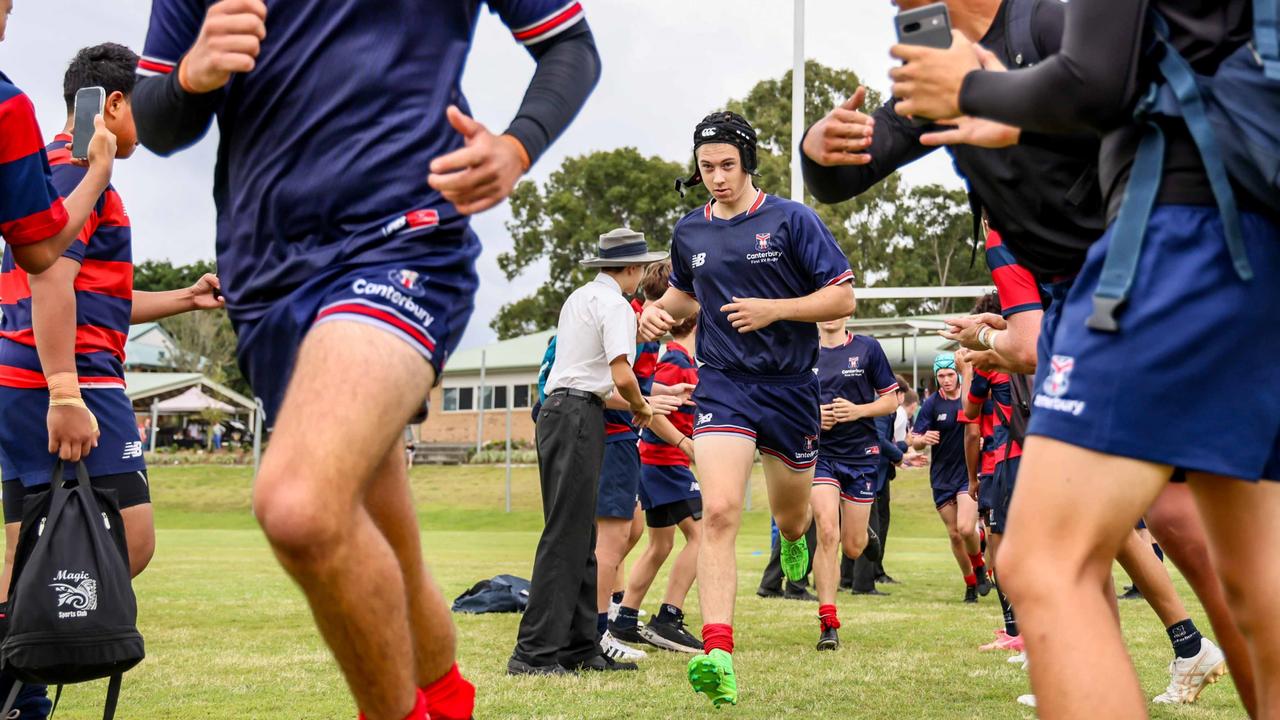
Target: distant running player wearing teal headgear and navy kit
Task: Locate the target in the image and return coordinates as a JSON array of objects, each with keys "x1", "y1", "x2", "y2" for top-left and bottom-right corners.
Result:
[{"x1": 910, "y1": 352, "x2": 991, "y2": 602}]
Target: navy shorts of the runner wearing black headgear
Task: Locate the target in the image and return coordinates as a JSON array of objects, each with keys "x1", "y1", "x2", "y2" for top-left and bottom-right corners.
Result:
[{"x1": 694, "y1": 365, "x2": 822, "y2": 470}]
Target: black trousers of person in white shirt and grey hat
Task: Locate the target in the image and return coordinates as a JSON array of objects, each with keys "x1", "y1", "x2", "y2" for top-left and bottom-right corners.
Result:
[{"x1": 512, "y1": 395, "x2": 604, "y2": 665}]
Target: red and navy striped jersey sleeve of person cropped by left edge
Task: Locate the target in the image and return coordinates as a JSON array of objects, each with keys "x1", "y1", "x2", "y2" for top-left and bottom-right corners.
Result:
[{"x1": 0, "y1": 73, "x2": 67, "y2": 245}]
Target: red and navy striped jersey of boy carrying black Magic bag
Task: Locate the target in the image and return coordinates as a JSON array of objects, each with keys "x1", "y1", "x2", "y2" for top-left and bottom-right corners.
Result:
[{"x1": 0, "y1": 135, "x2": 133, "y2": 388}]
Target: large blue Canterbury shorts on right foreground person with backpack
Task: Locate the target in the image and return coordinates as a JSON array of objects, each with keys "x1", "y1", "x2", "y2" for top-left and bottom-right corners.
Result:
[{"x1": 1029, "y1": 205, "x2": 1280, "y2": 479}]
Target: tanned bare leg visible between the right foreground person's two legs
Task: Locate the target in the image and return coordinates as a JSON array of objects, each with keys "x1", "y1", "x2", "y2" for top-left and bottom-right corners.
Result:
[{"x1": 1147, "y1": 483, "x2": 1258, "y2": 717}]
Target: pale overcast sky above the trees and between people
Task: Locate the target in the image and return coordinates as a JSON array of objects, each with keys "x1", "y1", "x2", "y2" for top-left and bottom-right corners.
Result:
[{"x1": 0, "y1": 0, "x2": 960, "y2": 348}]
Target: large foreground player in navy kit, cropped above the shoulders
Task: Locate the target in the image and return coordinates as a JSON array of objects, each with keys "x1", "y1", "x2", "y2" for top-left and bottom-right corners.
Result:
[{"x1": 134, "y1": 0, "x2": 599, "y2": 720}]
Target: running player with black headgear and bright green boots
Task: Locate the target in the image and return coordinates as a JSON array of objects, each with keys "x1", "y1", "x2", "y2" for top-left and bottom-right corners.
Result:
[{"x1": 640, "y1": 113, "x2": 854, "y2": 706}]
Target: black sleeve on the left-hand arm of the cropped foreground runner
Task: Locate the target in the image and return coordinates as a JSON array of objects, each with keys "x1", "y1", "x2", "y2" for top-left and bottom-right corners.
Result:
[{"x1": 132, "y1": 69, "x2": 223, "y2": 155}]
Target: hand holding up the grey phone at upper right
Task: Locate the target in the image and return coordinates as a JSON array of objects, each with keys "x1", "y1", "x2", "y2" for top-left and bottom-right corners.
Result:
[{"x1": 888, "y1": 29, "x2": 982, "y2": 120}]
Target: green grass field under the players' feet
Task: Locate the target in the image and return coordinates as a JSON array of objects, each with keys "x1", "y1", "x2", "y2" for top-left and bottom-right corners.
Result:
[{"x1": 45, "y1": 466, "x2": 1244, "y2": 720}]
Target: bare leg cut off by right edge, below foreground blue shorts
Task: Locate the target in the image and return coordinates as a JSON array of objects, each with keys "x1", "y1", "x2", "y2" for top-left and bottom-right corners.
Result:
[{"x1": 1188, "y1": 474, "x2": 1280, "y2": 720}]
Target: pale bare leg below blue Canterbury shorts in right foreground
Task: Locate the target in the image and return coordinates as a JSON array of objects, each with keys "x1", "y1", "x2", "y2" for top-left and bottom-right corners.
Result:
[{"x1": 997, "y1": 436, "x2": 1170, "y2": 720}]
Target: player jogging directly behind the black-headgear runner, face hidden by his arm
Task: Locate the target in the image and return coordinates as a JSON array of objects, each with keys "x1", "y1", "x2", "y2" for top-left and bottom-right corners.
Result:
[{"x1": 810, "y1": 318, "x2": 897, "y2": 650}]
